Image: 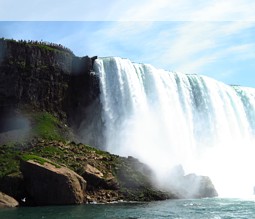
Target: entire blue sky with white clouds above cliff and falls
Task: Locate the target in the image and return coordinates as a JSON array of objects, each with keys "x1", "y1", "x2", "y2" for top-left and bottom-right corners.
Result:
[{"x1": 0, "y1": 0, "x2": 255, "y2": 87}]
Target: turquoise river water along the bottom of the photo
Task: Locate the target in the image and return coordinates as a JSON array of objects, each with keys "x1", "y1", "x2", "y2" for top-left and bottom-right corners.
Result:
[{"x1": 0, "y1": 198, "x2": 255, "y2": 219}]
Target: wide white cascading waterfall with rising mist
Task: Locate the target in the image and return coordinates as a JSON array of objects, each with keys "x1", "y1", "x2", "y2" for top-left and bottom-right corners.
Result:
[{"x1": 94, "y1": 57, "x2": 255, "y2": 196}]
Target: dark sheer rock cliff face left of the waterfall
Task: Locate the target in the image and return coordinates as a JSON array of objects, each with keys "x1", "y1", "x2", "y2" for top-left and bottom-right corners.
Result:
[{"x1": 0, "y1": 39, "x2": 99, "y2": 132}]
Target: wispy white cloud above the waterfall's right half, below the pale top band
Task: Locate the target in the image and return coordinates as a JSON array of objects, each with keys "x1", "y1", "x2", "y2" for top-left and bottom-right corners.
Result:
[{"x1": 153, "y1": 22, "x2": 255, "y2": 73}]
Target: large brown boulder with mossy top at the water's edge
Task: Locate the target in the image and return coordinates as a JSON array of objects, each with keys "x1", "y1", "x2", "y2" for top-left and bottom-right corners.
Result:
[{"x1": 21, "y1": 158, "x2": 86, "y2": 205}]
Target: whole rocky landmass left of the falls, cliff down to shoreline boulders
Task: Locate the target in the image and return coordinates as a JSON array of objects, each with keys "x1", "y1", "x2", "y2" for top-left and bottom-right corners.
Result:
[{"x1": 0, "y1": 38, "x2": 217, "y2": 207}]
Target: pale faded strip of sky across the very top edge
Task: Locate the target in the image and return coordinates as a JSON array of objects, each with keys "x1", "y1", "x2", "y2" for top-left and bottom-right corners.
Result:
[{"x1": 0, "y1": 0, "x2": 255, "y2": 21}]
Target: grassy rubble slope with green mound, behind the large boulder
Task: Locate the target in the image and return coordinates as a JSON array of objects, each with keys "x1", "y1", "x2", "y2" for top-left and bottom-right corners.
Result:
[{"x1": 0, "y1": 112, "x2": 174, "y2": 201}]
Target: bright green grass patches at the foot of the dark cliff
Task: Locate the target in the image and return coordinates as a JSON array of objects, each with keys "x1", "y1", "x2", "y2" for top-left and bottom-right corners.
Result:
[{"x1": 0, "y1": 112, "x2": 68, "y2": 177}]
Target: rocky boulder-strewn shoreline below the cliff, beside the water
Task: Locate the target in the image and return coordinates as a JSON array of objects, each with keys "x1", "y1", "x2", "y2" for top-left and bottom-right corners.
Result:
[{"x1": 0, "y1": 139, "x2": 217, "y2": 206}]
